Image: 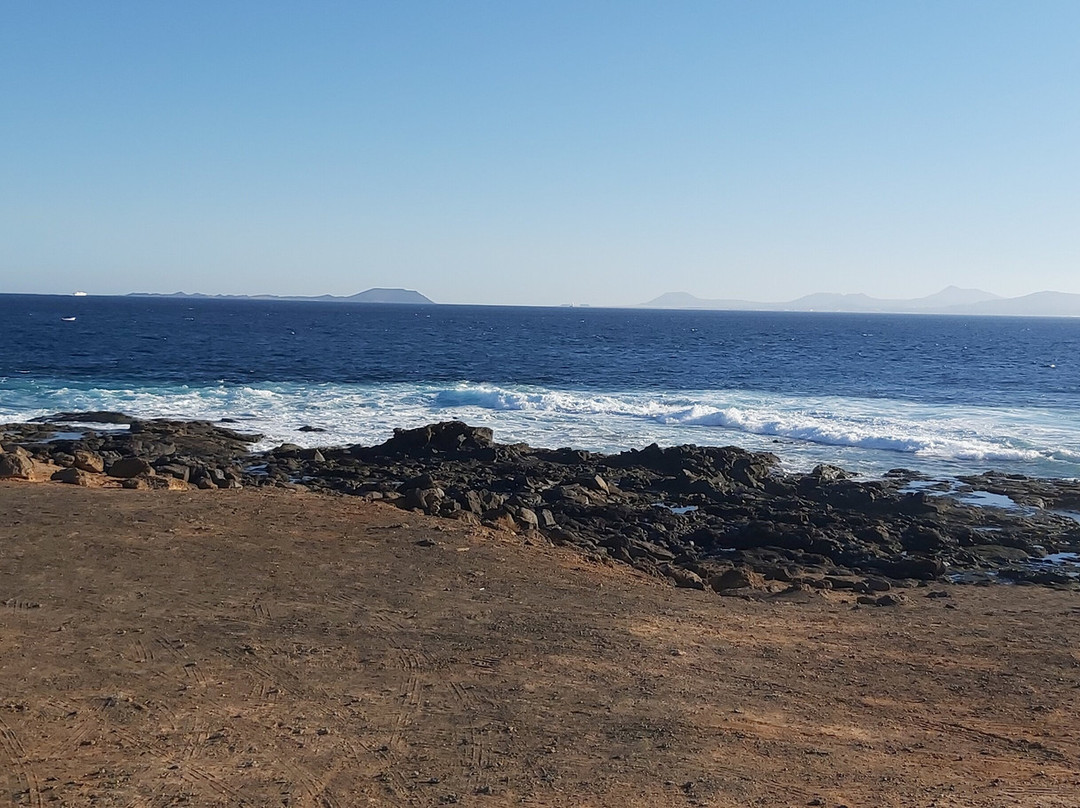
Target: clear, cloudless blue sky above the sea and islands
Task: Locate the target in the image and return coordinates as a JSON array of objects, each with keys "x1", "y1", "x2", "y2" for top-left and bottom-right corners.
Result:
[{"x1": 0, "y1": 0, "x2": 1080, "y2": 305}]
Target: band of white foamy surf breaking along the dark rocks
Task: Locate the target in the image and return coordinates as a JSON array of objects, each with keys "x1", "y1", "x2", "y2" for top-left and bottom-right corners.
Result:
[{"x1": 0, "y1": 378, "x2": 1080, "y2": 476}]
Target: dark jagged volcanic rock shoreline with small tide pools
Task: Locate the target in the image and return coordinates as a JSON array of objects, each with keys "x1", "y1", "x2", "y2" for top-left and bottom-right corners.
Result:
[{"x1": 0, "y1": 413, "x2": 1080, "y2": 606}]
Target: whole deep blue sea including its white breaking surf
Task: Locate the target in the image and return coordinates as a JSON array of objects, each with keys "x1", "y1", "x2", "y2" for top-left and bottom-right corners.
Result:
[{"x1": 0, "y1": 295, "x2": 1080, "y2": 477}]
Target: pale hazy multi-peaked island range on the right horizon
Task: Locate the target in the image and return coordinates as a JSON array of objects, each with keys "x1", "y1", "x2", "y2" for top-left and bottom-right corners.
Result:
[{"x1": 638, "y1": 286, "x2": 1080, "y2": 317}]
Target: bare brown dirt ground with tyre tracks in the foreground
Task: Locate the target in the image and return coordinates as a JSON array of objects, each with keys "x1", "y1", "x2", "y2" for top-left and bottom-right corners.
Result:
[{"x1": 0, "y1": 483, "x2": 1080, "y2": 808}]
